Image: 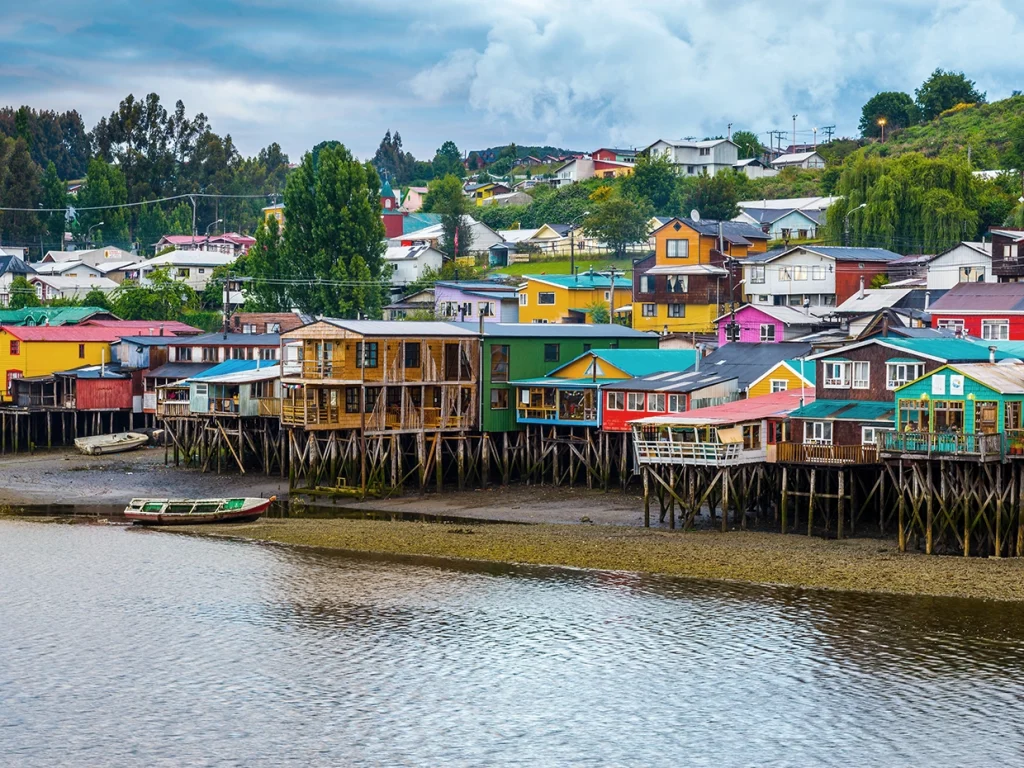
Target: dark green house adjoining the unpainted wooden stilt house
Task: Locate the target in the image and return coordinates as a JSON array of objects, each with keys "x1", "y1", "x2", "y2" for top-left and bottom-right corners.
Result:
[{"x1": 457, "y1": 323, "x2": 658, "y2": 432}]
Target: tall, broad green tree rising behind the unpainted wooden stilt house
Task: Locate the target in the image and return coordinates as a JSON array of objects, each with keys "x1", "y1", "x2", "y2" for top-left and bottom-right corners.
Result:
[{"x1": 283, "y1": 144, "x2": 386, "y2": 317}]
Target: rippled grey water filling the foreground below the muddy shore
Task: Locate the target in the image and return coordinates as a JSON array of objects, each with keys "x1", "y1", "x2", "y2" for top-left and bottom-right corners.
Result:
[{"x1": 0, "y1": 521, "x2": 1024, "y2": 766}]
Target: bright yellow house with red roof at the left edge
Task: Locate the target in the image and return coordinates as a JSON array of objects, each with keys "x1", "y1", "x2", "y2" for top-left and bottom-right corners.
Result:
[{"x1": 0, "y1": 326, "x2": 117, "y2": 400}]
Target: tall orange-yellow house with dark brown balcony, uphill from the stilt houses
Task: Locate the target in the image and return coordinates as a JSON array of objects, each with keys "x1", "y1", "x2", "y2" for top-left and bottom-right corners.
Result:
[{"x1": 632, "y1": 218, "x2": 768, "y2": 333}]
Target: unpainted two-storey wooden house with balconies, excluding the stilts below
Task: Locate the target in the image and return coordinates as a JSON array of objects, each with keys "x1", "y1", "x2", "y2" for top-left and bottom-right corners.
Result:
[{"x1": 282, "y1": 318, "x2": 480, "y2": 433}]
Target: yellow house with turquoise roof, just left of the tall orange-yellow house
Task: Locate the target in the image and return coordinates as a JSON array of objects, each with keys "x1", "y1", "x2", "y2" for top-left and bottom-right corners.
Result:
[{"x1": 516, "y1": 272, "x2": 632, "y2": 323}]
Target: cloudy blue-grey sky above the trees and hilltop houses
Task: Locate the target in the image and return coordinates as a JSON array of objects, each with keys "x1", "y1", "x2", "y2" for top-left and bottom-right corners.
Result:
[{"x1": 0, "y1": 0, "x2": 1024, "y2": 159}]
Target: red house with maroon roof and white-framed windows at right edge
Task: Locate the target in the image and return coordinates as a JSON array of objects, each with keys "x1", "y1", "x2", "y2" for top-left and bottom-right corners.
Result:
[{"x1": 930, "y1": 283, "x2": 1024, "y2": 341}]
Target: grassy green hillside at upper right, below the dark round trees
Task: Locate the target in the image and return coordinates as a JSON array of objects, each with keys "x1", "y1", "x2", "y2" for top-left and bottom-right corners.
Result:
[{"x1": 863, "y1": 96, "x2": 1024, "y2": 170}]
